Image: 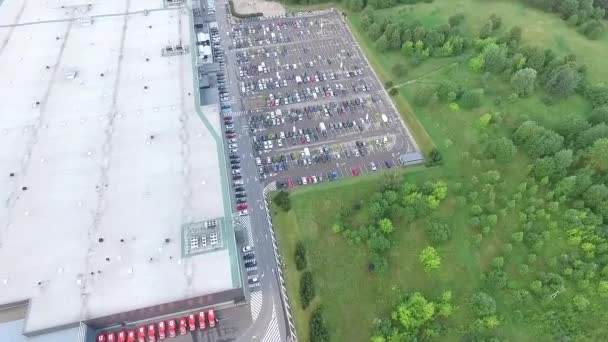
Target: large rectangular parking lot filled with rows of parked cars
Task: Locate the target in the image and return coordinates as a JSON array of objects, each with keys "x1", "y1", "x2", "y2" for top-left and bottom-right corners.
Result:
[{"x1": 225, "y1": 10, "x2": 417, "y2": 192}]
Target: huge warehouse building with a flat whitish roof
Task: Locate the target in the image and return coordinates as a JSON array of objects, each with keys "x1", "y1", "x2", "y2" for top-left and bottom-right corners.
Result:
[{"x1": 0, "y1": 0, "x2": 243, "y2": 341}]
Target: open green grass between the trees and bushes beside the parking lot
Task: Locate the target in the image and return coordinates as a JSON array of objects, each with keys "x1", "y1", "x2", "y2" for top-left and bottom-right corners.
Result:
[{"x1": 273, "y1": 0, "x2": 608, "y2": 342}]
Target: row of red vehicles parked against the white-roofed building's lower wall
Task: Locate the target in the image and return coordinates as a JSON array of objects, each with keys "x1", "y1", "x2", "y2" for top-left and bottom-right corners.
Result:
[{"x1": 97, "y1": 310, "x2": 217, "y2": 342}]
